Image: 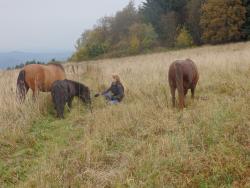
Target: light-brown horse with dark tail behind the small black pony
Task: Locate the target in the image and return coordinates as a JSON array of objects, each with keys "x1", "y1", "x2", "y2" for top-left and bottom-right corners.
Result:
[{"x1": 17, "y1": 63, "x2": 66, "y2": 101}]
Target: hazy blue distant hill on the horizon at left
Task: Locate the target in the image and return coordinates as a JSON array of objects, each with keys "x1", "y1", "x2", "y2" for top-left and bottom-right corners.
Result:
[{"x1": 0, "y1": 51, "x2": 72, "y2": 69}]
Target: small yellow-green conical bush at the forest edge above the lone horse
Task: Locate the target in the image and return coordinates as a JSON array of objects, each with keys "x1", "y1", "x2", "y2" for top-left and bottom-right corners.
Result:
[{"x1": 175, "y1": 27, "x2": 194, "y2": 48}]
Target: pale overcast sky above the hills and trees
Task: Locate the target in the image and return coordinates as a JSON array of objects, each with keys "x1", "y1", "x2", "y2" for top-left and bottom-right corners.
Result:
[{"x1": 0, "y1": 0, "x2": 143, "y2": 52}]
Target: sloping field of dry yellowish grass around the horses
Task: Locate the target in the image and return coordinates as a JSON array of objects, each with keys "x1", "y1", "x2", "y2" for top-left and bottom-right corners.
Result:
[{"x1": 0, "y1": 43, "x2": 250, "y2": 188}]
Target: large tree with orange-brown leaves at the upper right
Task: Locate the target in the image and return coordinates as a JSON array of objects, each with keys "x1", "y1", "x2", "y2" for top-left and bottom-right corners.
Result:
[{"x1": 200, "y1": 0, "x2": 246, "y2": 44}]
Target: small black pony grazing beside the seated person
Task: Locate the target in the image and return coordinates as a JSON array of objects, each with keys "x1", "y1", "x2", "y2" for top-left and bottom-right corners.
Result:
[{"x1": 51, "y1": 80, "x2": 92, "y2": 118}]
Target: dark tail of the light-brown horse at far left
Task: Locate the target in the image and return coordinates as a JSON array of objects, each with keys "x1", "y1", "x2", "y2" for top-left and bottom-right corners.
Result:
[{"x1": 16, "y1": 70, "x2": 29, "y2": 101}]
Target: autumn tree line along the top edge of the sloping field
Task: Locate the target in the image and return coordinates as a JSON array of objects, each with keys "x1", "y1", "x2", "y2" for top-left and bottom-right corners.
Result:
[{"x1": 71, "y1": 0, "x2": 250, "y2": 61}]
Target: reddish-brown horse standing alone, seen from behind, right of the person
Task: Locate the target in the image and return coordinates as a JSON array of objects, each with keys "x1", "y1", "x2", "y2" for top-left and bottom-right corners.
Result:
[{"x1": 168, "y1": 59, "x2": 199, "y2": 109}]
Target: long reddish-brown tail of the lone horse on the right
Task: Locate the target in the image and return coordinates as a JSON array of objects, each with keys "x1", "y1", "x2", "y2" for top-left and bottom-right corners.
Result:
[{"x1": 175, "y1": 62, "x2": 184, "y2": 109}]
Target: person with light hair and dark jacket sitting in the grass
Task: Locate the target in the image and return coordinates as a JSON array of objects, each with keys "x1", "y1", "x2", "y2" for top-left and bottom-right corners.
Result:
[{"x1": 98, "y1": 74, "x2": 124, "y2": 104}]
